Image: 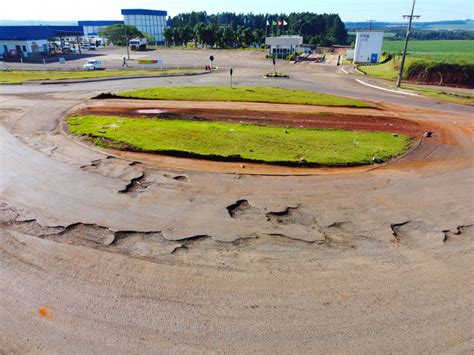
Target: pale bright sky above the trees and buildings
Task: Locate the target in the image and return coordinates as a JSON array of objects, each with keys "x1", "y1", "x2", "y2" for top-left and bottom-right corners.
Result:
[{"x1": 0, "y1": 0, "x2": 474, "y2": 22}]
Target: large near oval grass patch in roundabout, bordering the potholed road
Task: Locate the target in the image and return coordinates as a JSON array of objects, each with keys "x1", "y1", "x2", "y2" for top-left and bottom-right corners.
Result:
[{"x1": 67, "y1": 116, "x2": 410, "y2": 166}]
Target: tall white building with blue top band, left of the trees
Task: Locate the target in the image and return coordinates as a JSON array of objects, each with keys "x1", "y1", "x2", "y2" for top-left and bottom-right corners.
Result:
[{"x1": 122, "y1": 9, "x2": 168, "y2": 44}]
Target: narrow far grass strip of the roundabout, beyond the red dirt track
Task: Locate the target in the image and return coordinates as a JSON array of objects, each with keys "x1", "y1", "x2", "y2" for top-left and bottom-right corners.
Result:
[{"x1": 118, "y1": 86, "x2": 372, "y2": 107}]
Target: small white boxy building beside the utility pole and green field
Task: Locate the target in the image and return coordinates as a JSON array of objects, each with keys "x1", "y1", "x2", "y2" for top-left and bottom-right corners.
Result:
[{"x1": 354, "y1": 31, "x2": 383, "y2": 64}]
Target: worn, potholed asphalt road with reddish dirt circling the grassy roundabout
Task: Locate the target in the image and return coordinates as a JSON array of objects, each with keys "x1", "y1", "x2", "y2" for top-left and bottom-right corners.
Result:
[{"x1": 0, "y1": 51, "x2": 474, "y2": 354}]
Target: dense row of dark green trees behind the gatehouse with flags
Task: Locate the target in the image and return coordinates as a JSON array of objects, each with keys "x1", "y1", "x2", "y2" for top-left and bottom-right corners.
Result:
[{"x1": 164, "y1": 12, "x2": 347, "y2": 48}]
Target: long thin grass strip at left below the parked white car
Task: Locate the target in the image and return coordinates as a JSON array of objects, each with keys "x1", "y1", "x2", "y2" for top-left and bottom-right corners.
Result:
[{"x1": 0, "y1": 69, "x2": 202, "y2": 84}]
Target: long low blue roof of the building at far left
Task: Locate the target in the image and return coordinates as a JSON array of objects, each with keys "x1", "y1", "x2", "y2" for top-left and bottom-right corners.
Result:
[{"x1": 0, "y1": 26, "x2": 84, "y2": 41}]
